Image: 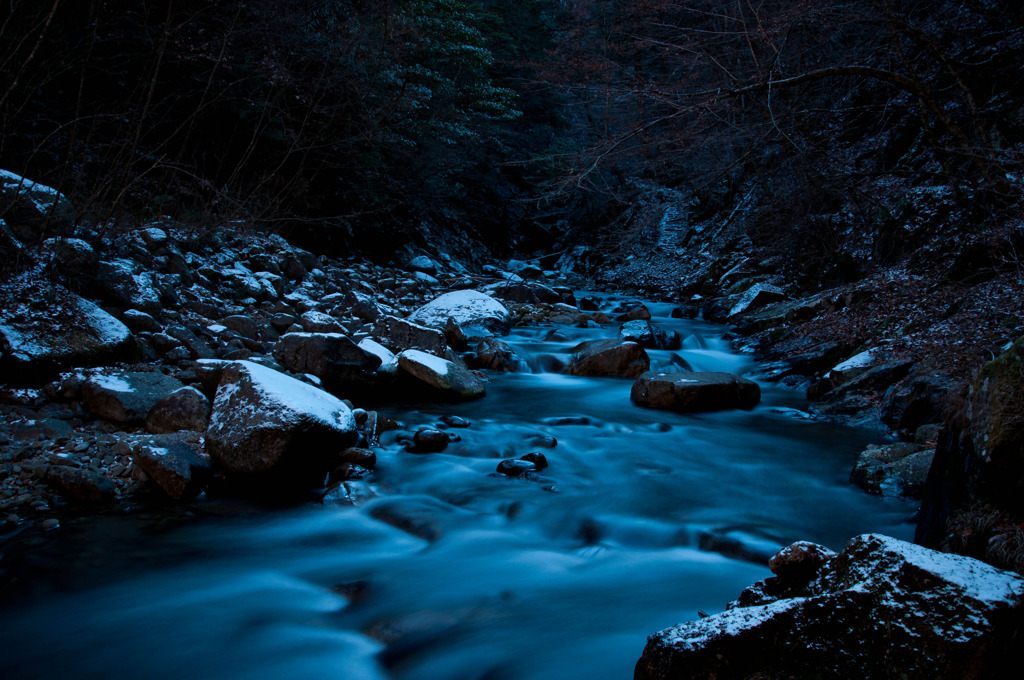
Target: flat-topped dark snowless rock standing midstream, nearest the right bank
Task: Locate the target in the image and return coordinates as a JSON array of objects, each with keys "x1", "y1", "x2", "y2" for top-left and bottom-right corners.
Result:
[{"x1": 630, "y1": 371, "x2": 761, "y2": 413}]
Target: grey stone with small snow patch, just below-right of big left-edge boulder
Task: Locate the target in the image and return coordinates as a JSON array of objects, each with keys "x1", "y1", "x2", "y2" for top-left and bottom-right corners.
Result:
[{"x1": 82, "y1": 371, "x2": 184, "y2": 423}]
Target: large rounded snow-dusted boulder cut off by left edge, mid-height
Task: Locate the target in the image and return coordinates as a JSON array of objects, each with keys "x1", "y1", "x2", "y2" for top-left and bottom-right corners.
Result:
[{"x1": 0, "y1": 282, "x2": 137, "y2": 380}]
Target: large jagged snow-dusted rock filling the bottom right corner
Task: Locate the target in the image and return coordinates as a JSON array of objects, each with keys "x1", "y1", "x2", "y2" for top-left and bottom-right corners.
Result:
[{"x1": 634, "y1": 535, "x2": 1024, "y2": 680}]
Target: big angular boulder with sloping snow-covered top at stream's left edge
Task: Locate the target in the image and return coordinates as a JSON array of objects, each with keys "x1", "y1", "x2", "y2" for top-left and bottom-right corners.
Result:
[{"x1": 206, "y1": 362, "x2": 357, "y2": 485}]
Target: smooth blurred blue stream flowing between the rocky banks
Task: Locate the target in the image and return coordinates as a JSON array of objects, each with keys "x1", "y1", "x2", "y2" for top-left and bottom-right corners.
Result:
[{"x1": 0, "y1": 300, "x2": 912, "y2": 680}]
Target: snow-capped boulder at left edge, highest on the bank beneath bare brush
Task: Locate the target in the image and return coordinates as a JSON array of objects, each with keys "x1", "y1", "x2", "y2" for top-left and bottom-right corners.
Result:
[{"x1": 0, "y1": 170, "x2": 75, "y2": 244}]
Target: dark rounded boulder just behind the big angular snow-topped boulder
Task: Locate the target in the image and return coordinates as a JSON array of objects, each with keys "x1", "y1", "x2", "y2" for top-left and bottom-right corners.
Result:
[{"x1": 273, "y1": 333, "x2": 382, "y2": 395}]
